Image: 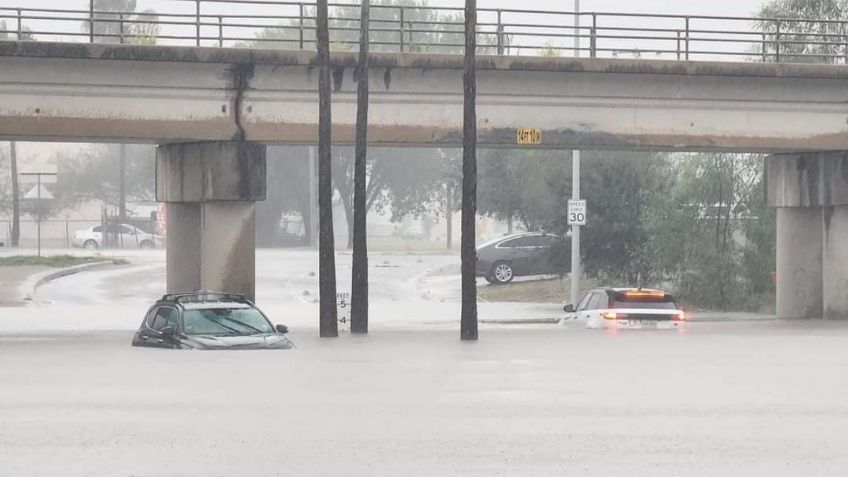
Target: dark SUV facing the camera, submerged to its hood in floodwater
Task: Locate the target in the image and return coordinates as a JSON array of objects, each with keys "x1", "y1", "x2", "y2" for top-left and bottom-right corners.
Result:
[{"x1": 132, "y1": 292, "x2": 293, "y2": 350}]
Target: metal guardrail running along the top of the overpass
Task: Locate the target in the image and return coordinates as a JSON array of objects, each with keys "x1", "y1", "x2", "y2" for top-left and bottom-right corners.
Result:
[{"x1": 0, "y1": 0, "x2": 848, "y2": 63}]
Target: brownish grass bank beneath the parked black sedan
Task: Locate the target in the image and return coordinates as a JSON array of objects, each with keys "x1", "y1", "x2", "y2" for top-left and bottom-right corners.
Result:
[{"x1": 477, "y1": 278, "x2": 595, "y2": 303}]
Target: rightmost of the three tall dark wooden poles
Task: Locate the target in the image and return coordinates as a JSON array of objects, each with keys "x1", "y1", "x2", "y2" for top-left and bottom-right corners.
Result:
[{"x1": 460, "y1": 0, "x2": 477, "y2": 341}]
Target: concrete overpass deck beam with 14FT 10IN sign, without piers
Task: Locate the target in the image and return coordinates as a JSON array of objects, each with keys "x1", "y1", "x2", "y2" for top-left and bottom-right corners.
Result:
[{"x1": 0, "y1": 42, "x2": 848, "y2": 152}]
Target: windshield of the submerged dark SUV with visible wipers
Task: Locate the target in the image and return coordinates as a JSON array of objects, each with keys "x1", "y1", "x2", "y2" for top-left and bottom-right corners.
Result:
[{"x1": 183, "y1": 308, "x2": 273, "y2": 335}]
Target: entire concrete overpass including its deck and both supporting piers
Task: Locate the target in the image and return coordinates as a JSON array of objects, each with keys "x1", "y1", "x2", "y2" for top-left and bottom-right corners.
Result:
[{"x1": 0, "y1": 42, "x2": 848, "y2": 318}]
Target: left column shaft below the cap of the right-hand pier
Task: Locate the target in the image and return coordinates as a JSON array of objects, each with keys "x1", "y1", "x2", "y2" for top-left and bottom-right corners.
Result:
[{"x1": 777, "y1": 207, "x2": 822, "y2": 318}]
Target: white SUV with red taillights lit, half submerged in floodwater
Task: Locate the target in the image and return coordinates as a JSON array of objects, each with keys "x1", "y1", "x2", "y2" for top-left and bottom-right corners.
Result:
[{"x1": 562, "y1": 288, "x2": 686, "y2": 330}]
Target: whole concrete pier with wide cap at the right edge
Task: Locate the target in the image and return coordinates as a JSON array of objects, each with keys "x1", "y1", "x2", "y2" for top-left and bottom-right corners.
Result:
[{"x1": 766, "y1": 152, "x2": 848, "y2": 319}]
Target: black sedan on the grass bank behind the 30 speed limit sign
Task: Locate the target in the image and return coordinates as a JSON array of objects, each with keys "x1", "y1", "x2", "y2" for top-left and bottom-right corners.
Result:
[{"x1": 477, "y1": 232, "x2": 567, "y2": 284}]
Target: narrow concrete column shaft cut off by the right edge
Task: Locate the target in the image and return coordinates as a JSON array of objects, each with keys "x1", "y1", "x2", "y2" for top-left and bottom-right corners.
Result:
[{"x1": 822, "y1": 205, "x2": 848, "y2": 320}]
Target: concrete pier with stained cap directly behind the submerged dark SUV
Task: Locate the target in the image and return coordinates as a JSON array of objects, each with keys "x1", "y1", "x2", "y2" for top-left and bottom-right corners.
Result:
[{"x1": 156, "y1": 142, "x2": 266, "y2": 298}]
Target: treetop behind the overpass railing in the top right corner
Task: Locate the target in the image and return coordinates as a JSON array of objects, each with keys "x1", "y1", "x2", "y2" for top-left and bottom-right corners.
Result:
[{"x1": 755, "y1": 0, "x2": 848, "y2": 63}]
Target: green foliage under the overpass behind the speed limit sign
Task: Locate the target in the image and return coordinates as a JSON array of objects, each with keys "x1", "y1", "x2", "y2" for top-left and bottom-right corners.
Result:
[{"x1": 478, "y1": 150, "x2": 776, "y2": 310}]
